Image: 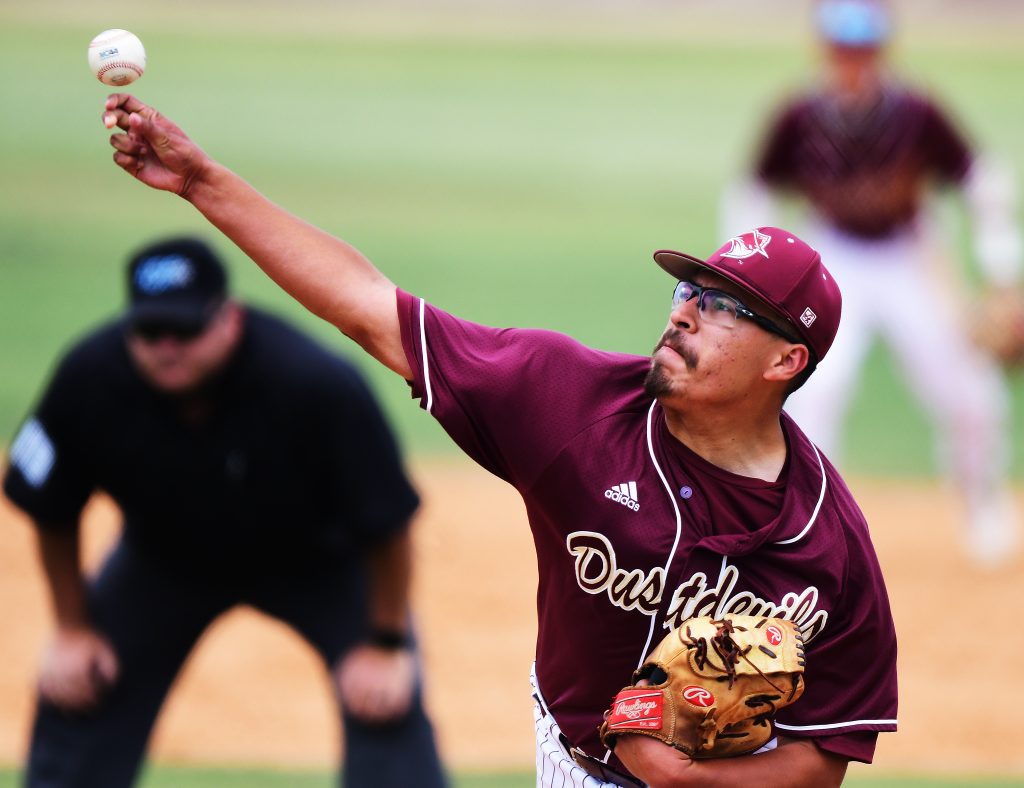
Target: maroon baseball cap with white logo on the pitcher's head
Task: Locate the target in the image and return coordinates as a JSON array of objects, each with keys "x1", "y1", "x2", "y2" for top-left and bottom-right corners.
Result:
[{"x1": 654, "y1": 227, "x2": 843, "y2": 361}]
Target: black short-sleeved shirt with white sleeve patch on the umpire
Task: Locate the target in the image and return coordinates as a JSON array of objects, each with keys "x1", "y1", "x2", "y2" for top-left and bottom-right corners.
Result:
[{"x1": 4, "y1": 309, "x2": 419, "y2": 563}]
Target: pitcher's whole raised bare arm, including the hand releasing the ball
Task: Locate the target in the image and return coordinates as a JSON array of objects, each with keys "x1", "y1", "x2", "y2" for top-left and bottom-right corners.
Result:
[{"x1": 103, "y1": 93, "x2": 412, "y2": 379}]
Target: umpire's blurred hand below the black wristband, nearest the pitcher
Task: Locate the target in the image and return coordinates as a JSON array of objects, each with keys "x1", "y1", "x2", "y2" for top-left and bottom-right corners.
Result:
[{"x1": 335, "y1": 644, "x2": 416, "y2": 723}]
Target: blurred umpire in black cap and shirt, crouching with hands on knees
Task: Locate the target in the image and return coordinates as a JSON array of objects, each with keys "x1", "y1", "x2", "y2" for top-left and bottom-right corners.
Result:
[{"x1": 4, "y1": 237, "x2": 444, "y2": 788}]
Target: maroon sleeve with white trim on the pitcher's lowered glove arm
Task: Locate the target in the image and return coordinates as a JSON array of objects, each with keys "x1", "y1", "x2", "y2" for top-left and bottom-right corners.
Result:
[{"x1": 776, "y1": 495, "x2": 897, "y2": 763}]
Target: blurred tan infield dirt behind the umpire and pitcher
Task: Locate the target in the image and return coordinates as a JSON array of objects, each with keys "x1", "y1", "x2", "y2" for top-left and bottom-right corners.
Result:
[{"x1": 0, "y1": 458, "x2": 1024, "y2": 775}]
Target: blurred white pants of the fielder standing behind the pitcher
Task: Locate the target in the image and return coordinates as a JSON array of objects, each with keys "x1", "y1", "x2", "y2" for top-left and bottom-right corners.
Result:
[{"x1": 785, "y1": 219, "x2": 1010, "y2": 528}]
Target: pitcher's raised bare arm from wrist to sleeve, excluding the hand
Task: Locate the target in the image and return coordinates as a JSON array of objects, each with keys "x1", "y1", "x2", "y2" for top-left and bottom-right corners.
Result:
[{"x1": 184, "y1": 162, "x2": 412, "y2": 379}]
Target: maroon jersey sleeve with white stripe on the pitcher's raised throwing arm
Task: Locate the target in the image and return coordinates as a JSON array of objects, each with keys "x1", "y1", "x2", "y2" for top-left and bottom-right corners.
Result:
[{"x1": 398, "y1": 291, "x2": 639, "y2": 489}]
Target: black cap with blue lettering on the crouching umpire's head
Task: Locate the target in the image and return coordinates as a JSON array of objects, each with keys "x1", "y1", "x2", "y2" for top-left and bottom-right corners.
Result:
[{"x1": 127, "y1": 237, "x2": 227, "y2": 329}]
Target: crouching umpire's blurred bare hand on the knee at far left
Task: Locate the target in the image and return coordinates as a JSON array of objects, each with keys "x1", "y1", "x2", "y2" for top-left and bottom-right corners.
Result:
[{"x1": 39, "y1": 627, "x2": 120, "y2": 712}]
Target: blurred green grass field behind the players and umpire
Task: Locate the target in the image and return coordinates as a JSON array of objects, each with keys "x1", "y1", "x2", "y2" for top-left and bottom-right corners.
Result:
[{"x1": 0, "y1": 0, "x2": 1024, "y2": 475}]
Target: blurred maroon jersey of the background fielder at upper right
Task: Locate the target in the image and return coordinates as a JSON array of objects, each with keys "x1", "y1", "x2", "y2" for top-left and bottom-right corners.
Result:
[{"x1": 756, "y1": 87, "x2": 971, "y2": 238}]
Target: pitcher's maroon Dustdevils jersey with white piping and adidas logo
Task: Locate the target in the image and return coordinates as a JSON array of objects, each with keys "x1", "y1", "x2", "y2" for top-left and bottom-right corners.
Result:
[{"x1": 398, "y1": 291, "x2": 896, "y2": 761}]
